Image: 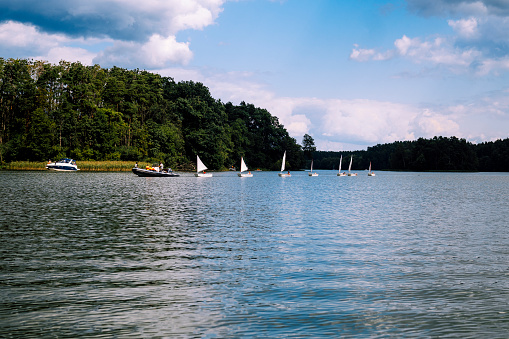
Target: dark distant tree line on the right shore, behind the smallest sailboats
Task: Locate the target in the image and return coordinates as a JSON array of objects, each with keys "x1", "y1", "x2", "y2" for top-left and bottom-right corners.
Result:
[{"x1": 313, "y1": 137, "x2": 509, "y2": 172}]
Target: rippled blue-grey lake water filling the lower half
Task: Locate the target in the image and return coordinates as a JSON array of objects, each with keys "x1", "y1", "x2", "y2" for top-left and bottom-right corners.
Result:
[{"x1": 0, "y1": 171, "x2": 509, "y2": 338}]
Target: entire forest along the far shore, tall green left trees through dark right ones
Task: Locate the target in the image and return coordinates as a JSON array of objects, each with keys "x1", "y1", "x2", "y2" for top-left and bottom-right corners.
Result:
[{"x1": 0, "y1": 58, "x2": 509, "y2": 172}]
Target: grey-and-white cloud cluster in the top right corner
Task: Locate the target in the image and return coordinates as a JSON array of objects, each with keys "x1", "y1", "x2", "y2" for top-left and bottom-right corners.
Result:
[{"x1": 350, "y1": 0, "x2": 509, "y2": 76}]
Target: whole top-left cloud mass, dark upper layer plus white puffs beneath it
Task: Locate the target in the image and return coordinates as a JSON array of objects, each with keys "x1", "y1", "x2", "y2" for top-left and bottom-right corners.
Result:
[{"x1": 0, "y1": 0, "x2": 225, "y2": 69}]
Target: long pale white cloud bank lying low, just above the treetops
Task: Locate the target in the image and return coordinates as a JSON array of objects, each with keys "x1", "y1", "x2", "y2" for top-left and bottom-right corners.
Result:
[{"x1": 158, "y1": 69, "x2": 509, "y2": 151}]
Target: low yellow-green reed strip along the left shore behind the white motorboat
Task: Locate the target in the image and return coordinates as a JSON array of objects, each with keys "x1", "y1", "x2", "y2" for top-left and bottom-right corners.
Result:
[{"x1": 1, "y1": 161, "x2": 151, "y2": 172}]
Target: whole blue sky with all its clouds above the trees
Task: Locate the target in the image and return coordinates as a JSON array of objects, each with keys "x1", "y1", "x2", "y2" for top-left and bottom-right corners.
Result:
[{"x1": 0, "y1": 0, "x2": 509, "y2": 151}]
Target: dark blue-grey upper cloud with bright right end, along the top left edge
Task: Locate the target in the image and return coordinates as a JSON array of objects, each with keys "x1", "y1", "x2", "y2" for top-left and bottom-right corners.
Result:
[{"x1": 0, "y1": 0, "x2": 225, "y2": 42}]
